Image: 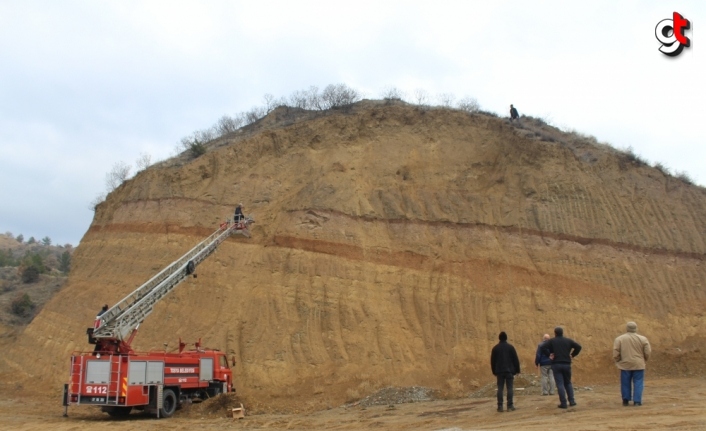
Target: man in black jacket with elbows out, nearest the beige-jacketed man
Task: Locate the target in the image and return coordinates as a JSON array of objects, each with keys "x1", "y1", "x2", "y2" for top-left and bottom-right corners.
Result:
[{"x1": 544, "y1": 326, "x2": 581, "y2": 409}]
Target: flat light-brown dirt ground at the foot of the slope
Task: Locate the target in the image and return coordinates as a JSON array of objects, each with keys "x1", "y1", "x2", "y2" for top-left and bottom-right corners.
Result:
[{"x1": 0, "y1": 375, "x2": 706, "y2": 431}]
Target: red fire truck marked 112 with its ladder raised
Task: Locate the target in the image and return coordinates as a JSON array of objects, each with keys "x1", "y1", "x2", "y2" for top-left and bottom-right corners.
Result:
[{"x1": 63, "y1": 218, "x2": 253, "y2": 418}]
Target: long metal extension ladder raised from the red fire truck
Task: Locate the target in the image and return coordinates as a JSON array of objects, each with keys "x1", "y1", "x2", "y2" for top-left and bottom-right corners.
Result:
[{"x1": 93, "y1": 224, "x2": 238, "y2": 340}]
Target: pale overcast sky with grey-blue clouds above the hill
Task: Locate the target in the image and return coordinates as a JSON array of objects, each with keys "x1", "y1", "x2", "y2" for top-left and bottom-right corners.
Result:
[{"x1": 0, "y1": 0, "x2": 706, "y2": 245}]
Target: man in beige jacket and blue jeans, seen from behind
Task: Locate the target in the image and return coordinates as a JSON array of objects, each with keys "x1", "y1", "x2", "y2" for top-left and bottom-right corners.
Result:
[{"x1": 613, "y1": 322, "x2": 652, "y2": 406}]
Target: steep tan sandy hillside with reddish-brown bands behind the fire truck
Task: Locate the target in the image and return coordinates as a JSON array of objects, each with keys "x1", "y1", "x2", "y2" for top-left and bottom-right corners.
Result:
[{"x1": 1, "y1": 103, "x2": 706, "y2": 408}]
